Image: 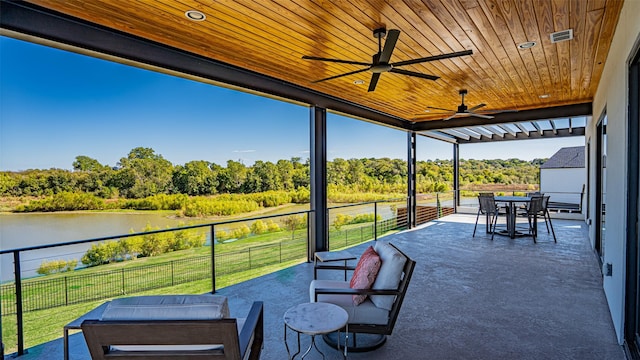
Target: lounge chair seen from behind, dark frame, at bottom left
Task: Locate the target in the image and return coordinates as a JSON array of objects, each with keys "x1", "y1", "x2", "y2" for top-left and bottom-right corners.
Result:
[{"x1": 81, "y1": 295, "x2": 264, "y2": 360}]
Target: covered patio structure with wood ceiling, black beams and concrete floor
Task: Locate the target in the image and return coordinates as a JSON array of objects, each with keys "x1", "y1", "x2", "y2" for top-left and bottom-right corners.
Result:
[{"x1": 1, "y1": 0, "x2": 640, "y2": 359}]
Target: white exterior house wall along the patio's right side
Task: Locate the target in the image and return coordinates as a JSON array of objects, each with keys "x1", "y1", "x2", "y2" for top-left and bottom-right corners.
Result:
[{"x1": 586, "y1": 0, "x2": 640, "y2": 344}]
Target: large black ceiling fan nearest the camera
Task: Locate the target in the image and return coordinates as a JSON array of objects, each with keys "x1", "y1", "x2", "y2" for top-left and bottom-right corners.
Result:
[{"x1": 302, "y1": 28, "x2": 473, "y2": 91}]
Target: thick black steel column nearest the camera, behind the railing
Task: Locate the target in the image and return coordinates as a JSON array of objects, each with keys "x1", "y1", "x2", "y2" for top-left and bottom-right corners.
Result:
[{"x1": 308, "y1": 106, "x2": 329, "y2": 261}]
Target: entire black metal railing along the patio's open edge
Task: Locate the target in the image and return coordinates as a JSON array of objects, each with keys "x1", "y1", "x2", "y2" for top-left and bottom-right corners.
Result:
[{"x1": 0, "y1": 193, "x2": 454, "y2": 354}]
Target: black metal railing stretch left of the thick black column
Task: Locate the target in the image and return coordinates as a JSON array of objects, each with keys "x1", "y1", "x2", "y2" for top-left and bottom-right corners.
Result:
[{"x1": 0, "y1": 211, "x2": 311, "y2": 354}]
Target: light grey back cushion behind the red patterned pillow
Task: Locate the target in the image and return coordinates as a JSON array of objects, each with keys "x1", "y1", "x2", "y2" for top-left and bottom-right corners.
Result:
[{"x1": 369, "y1": 241, "x2": 407, "y2": 310}]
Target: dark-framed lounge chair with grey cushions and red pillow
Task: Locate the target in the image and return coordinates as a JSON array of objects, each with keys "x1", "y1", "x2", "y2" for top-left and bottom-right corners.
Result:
[{"x1": 309, "y1": 241, "x2": 416, "y2": 352}]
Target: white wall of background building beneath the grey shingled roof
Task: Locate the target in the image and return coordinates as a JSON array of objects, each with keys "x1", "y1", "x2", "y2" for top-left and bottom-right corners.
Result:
[{"x1": 540, "y1": 168, "x2": 587, "y2": 204}]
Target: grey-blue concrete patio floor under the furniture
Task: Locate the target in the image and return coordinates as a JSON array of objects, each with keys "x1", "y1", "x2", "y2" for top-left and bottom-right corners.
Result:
[{"x1": 19, "y1": 214, "x2": 625, "y2": 360}]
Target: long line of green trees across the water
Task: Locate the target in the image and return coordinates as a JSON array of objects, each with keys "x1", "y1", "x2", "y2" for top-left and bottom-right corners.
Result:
[{"x1": 0, "y1": 147, "x2": 544, "y2": 199}]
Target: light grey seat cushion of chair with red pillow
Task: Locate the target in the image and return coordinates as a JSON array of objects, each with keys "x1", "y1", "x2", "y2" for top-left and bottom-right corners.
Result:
[{"x1": 309, "y1": 280, "x2": 389, "y2": 325}]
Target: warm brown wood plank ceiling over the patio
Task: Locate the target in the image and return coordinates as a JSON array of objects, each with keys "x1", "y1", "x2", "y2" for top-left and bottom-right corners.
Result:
[{"x1": 21, "y1": 0, "x2": 622, "y2": 122}]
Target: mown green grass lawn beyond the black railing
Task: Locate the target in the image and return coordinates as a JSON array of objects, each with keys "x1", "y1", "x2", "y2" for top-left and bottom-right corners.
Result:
[{"x1": 1, "y1": 217, "x2": 394, "y2": 353}]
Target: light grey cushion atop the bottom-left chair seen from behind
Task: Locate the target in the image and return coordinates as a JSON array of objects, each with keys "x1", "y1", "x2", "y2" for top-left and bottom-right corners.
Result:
[{"x1": 100, "y1": 295, "x2": 229, "y2": 321}]
